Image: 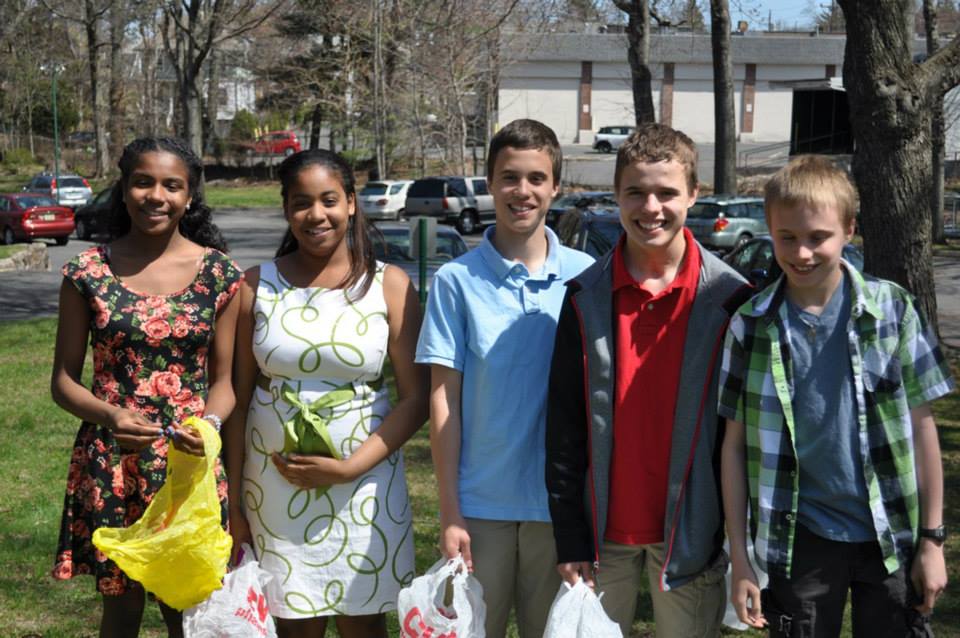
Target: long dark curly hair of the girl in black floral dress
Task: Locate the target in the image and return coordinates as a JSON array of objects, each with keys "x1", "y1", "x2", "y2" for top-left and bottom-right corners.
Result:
[{"x1": 110, "y1": 137, "x2": 227, "y2": 252}]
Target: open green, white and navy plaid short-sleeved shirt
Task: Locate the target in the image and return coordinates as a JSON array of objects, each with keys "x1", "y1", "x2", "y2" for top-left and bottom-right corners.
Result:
[{"x1": 718, "y1": 262, "x2": 954, "y2": 577}]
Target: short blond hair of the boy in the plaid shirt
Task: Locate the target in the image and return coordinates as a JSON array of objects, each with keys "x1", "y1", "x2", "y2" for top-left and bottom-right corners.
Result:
[{"x1": 763, "y1": 155, "x2": 857, "y2": 227}]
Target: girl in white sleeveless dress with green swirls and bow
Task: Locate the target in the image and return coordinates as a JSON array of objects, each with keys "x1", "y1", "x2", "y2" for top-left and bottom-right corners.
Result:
[{"x1": 225, "y1": 150, "x2": 428, "y2": 638}]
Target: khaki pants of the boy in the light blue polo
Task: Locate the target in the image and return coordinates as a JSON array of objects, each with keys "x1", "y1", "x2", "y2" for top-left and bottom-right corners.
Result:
[{"x1": 466, "y1": 518, "x2": 560, "y2": 638}]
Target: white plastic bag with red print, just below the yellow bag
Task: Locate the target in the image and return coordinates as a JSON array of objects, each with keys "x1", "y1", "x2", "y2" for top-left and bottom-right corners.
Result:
[{"x1": 183, "y1": 545, "x2": 277, "y2": 638}]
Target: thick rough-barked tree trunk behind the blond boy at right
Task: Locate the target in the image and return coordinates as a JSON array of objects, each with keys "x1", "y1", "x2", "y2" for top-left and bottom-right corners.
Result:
[{"x1": 839, "y1": 0, "x2": 960, "y2": 338}]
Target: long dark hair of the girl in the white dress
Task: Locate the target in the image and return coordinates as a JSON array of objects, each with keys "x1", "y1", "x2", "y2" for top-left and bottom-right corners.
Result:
[{"x1": 276, "y1": 149, "x2": 377, "y2": 299}]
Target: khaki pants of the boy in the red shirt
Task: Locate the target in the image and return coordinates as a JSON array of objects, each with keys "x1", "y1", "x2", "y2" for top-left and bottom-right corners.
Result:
[{"x1": 597, "y1": 541, "x2": 727, "y2": 638}]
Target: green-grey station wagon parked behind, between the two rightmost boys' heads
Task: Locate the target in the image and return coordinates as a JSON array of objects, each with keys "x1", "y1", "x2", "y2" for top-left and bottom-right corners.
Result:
[{"x1": 687, "y1": 195, "x2": 769, "y2": 252}]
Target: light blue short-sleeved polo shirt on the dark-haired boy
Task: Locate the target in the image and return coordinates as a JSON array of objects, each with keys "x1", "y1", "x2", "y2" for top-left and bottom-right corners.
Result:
[{"x1": 416, "y1": 227, "x2": 593, "y2": 521}]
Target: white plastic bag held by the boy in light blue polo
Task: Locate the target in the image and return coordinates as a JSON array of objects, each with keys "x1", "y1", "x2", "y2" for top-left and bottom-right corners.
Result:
[{"x1": 397, "y1": 556, "x2": 487, "y2": 638}]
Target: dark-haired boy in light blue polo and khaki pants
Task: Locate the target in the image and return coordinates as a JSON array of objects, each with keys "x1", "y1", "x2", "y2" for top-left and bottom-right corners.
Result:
[{"x1": 416, "y1": 120, "x2": 593, "y2": 638}]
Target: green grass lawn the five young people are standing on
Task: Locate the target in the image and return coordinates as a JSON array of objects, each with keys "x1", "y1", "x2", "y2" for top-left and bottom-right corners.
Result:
[{"x1": 0, "y1": 319, "x2": 960, "y2": 638}]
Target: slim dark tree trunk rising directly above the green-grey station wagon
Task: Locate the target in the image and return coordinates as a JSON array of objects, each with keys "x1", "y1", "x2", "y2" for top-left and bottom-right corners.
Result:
[{"x1": 710, "y1": 0, "x2": 737, "y2": 193}]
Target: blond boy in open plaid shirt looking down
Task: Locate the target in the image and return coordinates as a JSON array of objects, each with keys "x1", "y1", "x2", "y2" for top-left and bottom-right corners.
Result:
[{"x1": 718, "y1": 156, "x2": 953, "y2": 638}]
